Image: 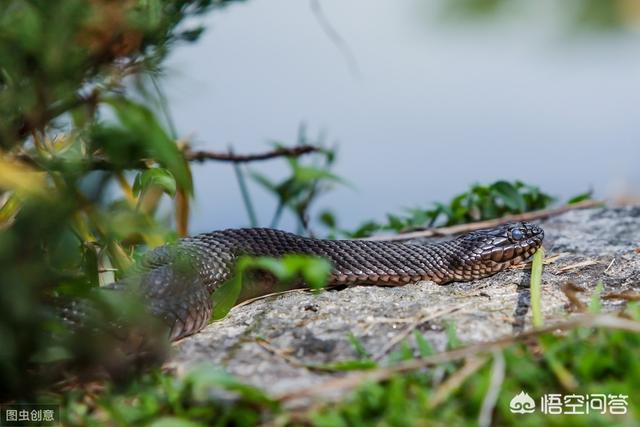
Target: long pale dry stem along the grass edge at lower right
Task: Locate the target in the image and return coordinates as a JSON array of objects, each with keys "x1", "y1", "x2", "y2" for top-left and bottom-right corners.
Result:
[{"x1": 276, "y1": 315, "x2": 640, "y2": 401}]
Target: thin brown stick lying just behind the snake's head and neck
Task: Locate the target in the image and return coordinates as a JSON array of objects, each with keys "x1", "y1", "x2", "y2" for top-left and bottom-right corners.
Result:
[{"x1": 363, "y1": 200, "x2": 605, "y2": 240}]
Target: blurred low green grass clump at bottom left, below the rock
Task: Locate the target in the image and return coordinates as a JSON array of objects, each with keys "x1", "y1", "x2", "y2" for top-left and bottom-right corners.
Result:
[{"x1": 62, "y1": 365, "x2": 278, "y2": 427}]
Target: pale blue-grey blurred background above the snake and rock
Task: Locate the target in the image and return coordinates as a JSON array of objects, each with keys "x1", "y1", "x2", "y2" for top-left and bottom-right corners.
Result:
[{"x1": 163, "y1": 0, "x2": 640, "y2": 232}]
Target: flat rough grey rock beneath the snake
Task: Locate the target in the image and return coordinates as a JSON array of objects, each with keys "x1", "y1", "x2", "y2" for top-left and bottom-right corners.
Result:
[{"x1": 169, "y1": 206, "x2": 640, "y2": 395}]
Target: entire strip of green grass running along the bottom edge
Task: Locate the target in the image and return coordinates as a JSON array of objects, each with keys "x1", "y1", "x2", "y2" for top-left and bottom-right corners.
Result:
[{"x1": 63, "y1": 304, "x2": 640, "y2": 426}]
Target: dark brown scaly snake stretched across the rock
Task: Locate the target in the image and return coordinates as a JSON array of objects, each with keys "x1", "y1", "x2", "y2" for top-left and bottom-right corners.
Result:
[{"x1": 69, "y1": 222, "x2": 544, "y2": 340}]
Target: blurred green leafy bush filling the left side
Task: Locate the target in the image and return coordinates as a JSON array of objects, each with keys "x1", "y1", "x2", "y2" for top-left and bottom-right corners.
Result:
[{"x1": 0, "y1": 0, "x2": 245, "y2": 398}]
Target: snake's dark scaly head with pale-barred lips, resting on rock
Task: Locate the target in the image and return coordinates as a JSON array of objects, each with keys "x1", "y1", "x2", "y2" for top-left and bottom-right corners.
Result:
[{"x1": 450, "y1": 221, "x2": 544, "y2": 281}]
